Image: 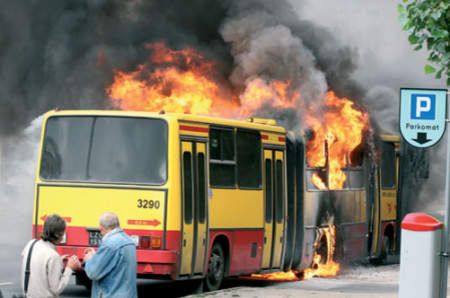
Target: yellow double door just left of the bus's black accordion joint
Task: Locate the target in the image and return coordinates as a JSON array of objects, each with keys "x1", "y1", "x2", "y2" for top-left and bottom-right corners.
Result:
[{"x1": 262, "y1": 149, "x2": 284, "y2": 269}]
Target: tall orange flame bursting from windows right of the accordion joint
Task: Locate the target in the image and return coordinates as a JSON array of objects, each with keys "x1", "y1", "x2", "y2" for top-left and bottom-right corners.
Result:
[{"x1": 306, "y1": 91, "x2": 369, "y2": 189}]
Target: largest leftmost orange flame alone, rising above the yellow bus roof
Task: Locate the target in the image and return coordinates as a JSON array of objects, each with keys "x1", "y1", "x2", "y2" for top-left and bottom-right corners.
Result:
[{"x1": 106, "y1": 42, "x2": 236, "y2": 115}]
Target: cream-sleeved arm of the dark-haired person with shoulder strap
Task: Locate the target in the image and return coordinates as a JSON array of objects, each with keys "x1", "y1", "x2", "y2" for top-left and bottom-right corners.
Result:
[{"x1": 47, "y1": 255, "x2": 73, "y2": 296}]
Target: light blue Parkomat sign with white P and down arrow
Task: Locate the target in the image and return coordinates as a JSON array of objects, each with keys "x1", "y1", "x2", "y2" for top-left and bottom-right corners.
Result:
[{"x1": 400, "y1": 88, "x2": 447, "y2": 148}]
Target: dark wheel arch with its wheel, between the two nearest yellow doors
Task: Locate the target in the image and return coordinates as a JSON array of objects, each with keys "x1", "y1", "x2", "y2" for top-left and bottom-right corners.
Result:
[{"x1": 204, "y1": 235, "x2": 230, "y2": 291}]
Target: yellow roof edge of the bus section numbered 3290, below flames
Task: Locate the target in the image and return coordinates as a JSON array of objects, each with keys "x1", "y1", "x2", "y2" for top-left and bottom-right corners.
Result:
[{"x1": 45, "y1": 110, "x2": 286, "y2": 134}]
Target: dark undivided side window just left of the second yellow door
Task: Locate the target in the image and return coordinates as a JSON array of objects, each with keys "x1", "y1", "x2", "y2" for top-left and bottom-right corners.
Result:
[{"x1": 236, "y1": 130, "x2": 261, "y2": 188}]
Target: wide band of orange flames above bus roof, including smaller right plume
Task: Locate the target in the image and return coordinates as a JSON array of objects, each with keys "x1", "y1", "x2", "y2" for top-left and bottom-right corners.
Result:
[{"x1": 106, "y1": 42, "x2": 300, "y2": 118}]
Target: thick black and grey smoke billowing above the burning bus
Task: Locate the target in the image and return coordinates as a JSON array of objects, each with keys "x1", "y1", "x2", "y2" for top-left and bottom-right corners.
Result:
[{"x1": 0, "y1": 0, "x2": 370, "y2": 134}]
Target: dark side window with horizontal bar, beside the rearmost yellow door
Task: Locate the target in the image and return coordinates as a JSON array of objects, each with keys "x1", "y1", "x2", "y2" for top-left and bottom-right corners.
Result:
[{"x1": 209, "y1": 128, "x2": 236, "y2": 187}]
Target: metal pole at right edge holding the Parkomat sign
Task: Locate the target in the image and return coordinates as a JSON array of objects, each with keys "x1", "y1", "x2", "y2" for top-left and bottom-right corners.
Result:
[{"x1": 439, "y1": 92, "x2": 450, "y2": 298}]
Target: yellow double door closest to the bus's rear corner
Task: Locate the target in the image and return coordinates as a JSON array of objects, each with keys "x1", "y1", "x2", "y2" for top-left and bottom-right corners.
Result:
[{"x1": 180, "y1": 141, "x2": 207, "y2": 275}]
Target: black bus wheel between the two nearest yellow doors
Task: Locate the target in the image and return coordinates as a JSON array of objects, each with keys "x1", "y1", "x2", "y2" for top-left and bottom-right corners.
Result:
[{"x1": 205, "y1": 243, "x2": 225, "y2": 291}]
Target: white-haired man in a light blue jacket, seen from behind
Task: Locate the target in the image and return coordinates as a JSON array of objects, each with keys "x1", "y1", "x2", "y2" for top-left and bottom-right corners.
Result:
[{"x1": 84, "y1": 212, "x2": 137, "y2": 298}]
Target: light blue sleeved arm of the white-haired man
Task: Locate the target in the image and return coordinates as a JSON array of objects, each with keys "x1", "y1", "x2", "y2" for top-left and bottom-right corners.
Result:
[{"x1": 84, "y1": 246, "x2": 119, "y2": 280}]
